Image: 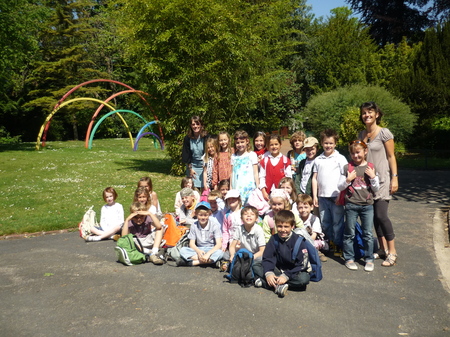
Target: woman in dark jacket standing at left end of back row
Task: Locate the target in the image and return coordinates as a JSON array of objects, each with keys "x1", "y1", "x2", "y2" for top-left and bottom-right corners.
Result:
[{"x1": 181, "y1": 116, "x2": 207, "y2": 189}]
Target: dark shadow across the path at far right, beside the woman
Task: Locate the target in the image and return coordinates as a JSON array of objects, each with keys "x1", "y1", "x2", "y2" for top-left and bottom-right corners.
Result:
[{"x1": 394, "y1": 170, "x2": 450, "y2": 205}]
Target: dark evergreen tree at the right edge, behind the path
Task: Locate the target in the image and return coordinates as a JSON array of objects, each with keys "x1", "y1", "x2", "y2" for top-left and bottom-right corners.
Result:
[{"x1": 390, "y1": 21, "x2": 450, "y2": 149}]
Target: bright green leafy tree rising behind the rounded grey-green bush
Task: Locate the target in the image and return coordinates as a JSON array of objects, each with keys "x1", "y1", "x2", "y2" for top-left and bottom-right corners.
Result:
[{"x1": 297, "y1": 7, "x2": 381, "y2": 101}]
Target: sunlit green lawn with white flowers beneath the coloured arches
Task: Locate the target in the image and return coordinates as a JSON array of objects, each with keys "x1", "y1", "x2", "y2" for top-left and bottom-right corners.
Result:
[{"x1": 0, "y1": 138, "x2": 181, "y2": 236}]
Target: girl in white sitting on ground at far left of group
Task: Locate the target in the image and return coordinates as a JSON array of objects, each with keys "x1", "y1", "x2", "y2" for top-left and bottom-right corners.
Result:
[{"x1": 84, "y1": 187, "x2": 124, "y2": 242}]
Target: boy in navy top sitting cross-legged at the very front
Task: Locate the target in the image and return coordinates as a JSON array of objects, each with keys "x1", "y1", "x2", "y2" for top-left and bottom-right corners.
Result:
[{"x1": 255, "y1": 210, "x2": 310, "y2": 297}]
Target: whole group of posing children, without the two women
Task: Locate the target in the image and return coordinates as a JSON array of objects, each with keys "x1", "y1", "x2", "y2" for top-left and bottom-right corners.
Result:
[{"x1": 81, "y1": 126, "x2": 379, "y2": 297}]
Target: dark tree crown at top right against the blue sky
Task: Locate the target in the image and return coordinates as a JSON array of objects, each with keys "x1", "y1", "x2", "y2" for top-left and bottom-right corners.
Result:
[{"x1": 346, "y1": 0, "x2": 433, "y2": 45}]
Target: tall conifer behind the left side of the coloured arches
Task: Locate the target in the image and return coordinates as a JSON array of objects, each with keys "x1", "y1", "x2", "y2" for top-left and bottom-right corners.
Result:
[{"x1": 24, "y1": 0, "x2": 108, "y2": 139}]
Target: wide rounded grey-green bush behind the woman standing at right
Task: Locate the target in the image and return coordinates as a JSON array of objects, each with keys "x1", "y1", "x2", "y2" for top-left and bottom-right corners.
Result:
[{"x1": 302, "y1": 85, "x2": 417, "y2": 142}]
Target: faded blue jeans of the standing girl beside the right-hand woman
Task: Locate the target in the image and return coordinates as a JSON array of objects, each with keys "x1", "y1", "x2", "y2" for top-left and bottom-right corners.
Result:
[{"x1": 343, "y1": 203, "x2": 373, "y2": 262}]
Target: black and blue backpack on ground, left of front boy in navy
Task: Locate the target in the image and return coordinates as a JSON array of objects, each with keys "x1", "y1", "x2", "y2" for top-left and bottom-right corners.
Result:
[{"x1": 225, "y1": 248, "x2": 255, "y2": 288}]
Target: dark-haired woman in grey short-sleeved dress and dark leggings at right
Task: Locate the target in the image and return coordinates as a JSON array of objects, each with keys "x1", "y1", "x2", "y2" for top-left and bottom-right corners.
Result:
[{"x1": 358, "y1": 102, "x2": 398, "y2": 267}]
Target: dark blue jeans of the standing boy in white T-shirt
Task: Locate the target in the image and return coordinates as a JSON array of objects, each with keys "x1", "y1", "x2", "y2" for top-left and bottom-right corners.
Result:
[{"x1": 319, "y1": 197, "x2": 345, "y2": 248}]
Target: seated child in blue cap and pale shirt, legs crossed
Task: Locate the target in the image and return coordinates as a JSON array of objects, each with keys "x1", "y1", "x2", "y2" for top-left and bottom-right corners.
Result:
[{"x1": 176, "y1": 201, "x2": 223, "y2": 266}]
